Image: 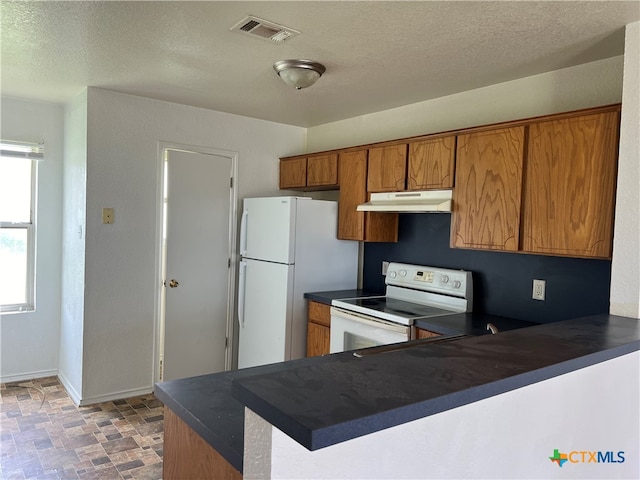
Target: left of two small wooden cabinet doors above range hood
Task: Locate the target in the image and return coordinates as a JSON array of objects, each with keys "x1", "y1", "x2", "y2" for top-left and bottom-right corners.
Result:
[{"x1": 367, "y1": 144, "x2": 407, "y2": 192}]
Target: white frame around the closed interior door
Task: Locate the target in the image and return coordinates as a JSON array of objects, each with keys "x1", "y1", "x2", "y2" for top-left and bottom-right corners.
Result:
[{"x1": 152, "y1": 141, "x2": 238, "y2": 384}]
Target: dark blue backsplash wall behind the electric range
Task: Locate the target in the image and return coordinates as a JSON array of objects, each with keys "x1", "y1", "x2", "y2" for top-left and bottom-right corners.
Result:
[{"x1": 363, "y1": 213, "x2": 611, "y2": 323}]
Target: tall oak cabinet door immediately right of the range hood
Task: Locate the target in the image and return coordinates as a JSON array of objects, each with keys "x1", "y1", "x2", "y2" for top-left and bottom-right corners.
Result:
[{"x1": 451, "y1": 127, "x2": 524, "y2": 252}]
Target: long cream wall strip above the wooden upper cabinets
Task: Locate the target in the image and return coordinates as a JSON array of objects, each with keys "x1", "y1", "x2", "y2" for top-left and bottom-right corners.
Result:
[{"x1": 307, "y1": 56, "x2": 623, "y2": 152}]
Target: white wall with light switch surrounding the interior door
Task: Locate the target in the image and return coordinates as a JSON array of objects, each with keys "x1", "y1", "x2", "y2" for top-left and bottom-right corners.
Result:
[{"x1": 81, "y1": 88, "x2": 305, "y2": 403}]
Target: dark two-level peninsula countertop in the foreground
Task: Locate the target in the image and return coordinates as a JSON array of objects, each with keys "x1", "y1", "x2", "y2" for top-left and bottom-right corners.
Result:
[{"x1": 155, "y1": 315, "x2": 640, "y2": 472}]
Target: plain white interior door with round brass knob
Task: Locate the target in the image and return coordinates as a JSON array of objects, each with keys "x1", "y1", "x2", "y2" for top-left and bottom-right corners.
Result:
[{"x1": 160, "y1": 149, "x2": 235, "y2": 381}]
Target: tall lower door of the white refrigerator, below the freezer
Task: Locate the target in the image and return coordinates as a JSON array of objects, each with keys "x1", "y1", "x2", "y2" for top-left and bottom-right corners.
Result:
[{"x1": 238, "y1": 259, "x2": 294, "y2": 368}]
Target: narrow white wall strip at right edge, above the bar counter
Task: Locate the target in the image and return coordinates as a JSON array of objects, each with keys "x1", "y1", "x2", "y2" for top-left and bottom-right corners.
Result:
[{"x1": 610, "y1": 22, "x2": 640, "y2": 318}]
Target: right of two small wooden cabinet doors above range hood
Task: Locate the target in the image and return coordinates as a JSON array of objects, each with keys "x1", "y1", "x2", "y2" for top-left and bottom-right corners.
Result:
[{"x1": 407, "y1": 136, "x2": 456, "y2": 190}]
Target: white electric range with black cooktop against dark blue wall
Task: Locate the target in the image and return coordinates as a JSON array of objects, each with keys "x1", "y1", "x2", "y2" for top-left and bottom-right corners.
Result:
[{"x1": 330, "y1": 262, "x2": 473, "y2": 353}]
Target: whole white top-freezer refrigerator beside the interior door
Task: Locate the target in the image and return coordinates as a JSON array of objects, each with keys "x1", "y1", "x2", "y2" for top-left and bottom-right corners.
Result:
[{"x1": 238, "y1": 197, "x2": 358, "y2": 368}]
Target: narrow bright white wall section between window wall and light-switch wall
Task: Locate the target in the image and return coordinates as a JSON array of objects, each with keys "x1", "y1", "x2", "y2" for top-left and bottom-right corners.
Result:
[{"x1": 58, "y1": 90, "x2": 87, "y2": 403}]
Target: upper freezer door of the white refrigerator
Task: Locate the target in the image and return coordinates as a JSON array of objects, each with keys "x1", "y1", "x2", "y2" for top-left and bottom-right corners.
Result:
[{"x1": 240, "y1": 197, "x2": 308, "y2": 263}]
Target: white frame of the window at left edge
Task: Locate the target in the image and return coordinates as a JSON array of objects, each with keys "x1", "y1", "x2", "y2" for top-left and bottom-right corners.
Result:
[{"x1": 0, "y1": 154, "x2": 38, "y2": 315}]
